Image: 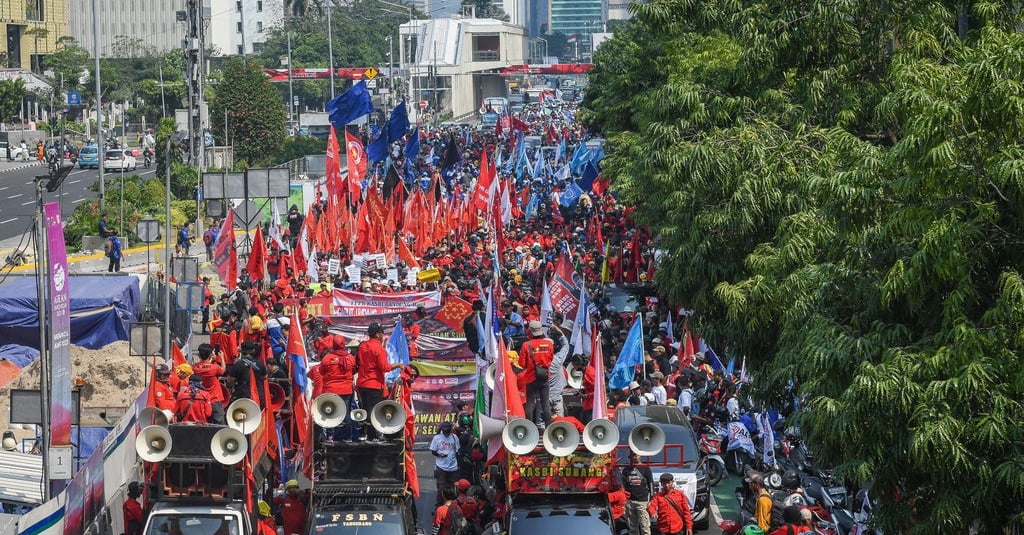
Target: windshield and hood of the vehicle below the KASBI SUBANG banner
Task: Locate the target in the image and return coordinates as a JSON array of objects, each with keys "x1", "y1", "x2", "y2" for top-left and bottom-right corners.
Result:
[{"x1": 507, "y1": 494, "x2": 614, "y2": 535}]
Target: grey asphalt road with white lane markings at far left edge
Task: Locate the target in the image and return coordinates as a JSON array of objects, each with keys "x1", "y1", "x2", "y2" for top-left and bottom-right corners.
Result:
[{"x1": 0, "y1": 155, "x2": 156, "y2": 242}]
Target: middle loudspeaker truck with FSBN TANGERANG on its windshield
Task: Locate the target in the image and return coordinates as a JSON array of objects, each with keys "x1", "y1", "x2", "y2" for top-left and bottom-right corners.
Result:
[{"x1": 308, "y1": 394, "x2": 419, "y2": 535}]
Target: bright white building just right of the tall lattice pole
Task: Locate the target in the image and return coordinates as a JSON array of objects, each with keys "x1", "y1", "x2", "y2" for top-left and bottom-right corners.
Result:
[{"x1": 206, "y1": 0, "x2": 285, "y2": 55}]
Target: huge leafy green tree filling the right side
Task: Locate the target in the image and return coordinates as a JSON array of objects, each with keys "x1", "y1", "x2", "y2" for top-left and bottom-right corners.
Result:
[{"x1": 586, "y1": 0, "x2": 1024, "y2": 533}]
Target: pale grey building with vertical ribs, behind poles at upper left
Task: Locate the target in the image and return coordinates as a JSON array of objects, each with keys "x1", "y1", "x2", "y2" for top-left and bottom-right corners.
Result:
[{"x1": 67, "y1": 0, "x2": 183, "y2": 57}]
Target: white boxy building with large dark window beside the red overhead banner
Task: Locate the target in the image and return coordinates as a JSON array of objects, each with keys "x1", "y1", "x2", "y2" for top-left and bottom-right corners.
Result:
[{"x1": 398, "y1": 18, "x2": 526, "y2": 119}]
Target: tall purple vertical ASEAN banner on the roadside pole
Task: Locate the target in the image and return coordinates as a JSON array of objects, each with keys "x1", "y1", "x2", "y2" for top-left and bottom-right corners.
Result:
[{"x1": 43, "y1": 203, "x2": 72, "y2": 447}]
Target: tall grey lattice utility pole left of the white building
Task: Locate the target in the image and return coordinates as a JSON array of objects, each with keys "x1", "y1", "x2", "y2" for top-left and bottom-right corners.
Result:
[{"x1": 183, "y1": 0, "x2": 206, "y2": 168}]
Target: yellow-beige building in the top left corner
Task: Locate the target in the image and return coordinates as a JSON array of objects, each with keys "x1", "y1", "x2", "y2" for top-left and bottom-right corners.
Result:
[{"x1": 0, "y1": 0, "x2": 68, "y2": 73}]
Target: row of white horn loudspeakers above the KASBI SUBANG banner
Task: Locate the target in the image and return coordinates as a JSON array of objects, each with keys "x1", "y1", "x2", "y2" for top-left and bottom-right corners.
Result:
[{"x1": 480, "y1": 415, "x2": 665, "y2": 457}]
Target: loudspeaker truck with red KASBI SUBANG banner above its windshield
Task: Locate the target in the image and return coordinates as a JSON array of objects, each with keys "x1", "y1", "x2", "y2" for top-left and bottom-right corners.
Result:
[{"x1": 481, "y1": 416, "x2": 618, "y2": 535}]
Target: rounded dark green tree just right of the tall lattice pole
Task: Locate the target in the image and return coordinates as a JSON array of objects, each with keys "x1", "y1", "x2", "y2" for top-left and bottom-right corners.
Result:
[{"x1": 210, "y1": 56, "x2": 286, "y2": 166}]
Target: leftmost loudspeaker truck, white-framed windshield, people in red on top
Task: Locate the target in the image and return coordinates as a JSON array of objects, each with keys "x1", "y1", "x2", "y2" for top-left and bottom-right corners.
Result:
[{"x1": 135, "y1": 399, "x2": 272, "y2": 535}]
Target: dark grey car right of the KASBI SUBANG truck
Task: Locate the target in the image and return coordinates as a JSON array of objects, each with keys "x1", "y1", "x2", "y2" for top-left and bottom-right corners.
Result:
[{"x1": 614, "y1": 405, "x2": 711, "y2": 530}]
